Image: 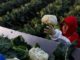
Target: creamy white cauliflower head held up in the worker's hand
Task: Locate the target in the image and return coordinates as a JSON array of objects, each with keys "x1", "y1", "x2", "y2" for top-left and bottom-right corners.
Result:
[{"x1": 41, "y1": 15, "x2": 58, "y2": 25}]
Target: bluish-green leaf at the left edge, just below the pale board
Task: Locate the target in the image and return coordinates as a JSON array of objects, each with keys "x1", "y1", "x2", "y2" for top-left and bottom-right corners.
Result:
[{"x1": 0, "y1": 37, "x2": 12, "y2": 52}]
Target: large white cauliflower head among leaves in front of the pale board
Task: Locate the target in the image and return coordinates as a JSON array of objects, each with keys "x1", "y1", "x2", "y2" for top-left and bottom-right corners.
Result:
[{"x1": 29, "y1": 47, "x2": 49, "y2": 60}]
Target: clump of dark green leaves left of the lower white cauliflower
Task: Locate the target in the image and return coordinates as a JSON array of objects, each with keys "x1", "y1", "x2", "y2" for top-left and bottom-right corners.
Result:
[{"x1": 0, "y1": 36, "x2": 31, "y2": 60}]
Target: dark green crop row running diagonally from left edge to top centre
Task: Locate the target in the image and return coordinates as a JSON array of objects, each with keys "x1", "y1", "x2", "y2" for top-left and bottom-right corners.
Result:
[{"x1": 0, "y1": 0, "x2": 54, "y2": 29}]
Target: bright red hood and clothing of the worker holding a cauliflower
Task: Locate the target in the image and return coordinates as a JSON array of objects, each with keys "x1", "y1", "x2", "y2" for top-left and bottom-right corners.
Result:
[{"x1": 61, "y1": 16, "x2": 80, "y2": 47}]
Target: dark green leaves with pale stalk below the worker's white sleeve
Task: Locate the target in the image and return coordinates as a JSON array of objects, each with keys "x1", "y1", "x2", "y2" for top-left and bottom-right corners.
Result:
[{"x1": 53, "y1": 40, "x2": 77, "y2": 60}]
